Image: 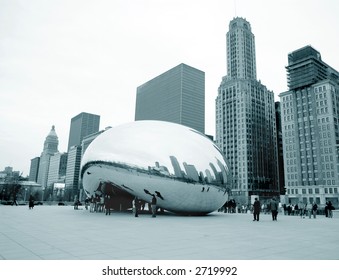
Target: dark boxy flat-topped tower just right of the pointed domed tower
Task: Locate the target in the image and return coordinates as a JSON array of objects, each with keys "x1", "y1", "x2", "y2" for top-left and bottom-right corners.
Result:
[{"x1": 67, "y1": 112, "x2": 100, "y2": 150}]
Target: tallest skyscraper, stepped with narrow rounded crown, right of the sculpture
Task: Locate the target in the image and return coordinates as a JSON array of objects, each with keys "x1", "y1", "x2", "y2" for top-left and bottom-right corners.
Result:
[{"x1": 216, "y1": 18, "x2": 279, "y2": 203}]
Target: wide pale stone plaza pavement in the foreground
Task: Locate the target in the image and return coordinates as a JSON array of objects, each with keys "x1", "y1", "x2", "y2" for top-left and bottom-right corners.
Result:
[{"x1": 0, "y1": 205, "x2": 339, "y2": 260}]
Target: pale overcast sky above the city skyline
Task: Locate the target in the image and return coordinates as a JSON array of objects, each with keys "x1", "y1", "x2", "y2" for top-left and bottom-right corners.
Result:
[{"x1": 0, "y1": 0, "x2": 339, "y2": 175}]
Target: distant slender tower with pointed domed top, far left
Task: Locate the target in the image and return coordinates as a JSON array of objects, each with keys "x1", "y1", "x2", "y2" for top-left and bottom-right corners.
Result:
[{"x1": 37, "y1": 125, "x2": 59, "y2": 188}]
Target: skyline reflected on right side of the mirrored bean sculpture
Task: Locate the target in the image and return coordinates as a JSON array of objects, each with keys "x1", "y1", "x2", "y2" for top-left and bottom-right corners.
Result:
[{"x1": 148, "y1": 155, "x2": 228, "y2": 187}]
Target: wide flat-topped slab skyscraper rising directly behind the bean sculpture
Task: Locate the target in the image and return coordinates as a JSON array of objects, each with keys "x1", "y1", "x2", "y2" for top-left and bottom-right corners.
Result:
[{"x1": 135, "y1": 64, "x2": 205, "y2": 133}]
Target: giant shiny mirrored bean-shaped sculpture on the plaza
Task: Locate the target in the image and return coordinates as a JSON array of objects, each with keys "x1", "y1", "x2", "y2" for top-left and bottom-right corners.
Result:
[{"x1": 81, "y1": 121, "x2": 230, "y2": 215}]
